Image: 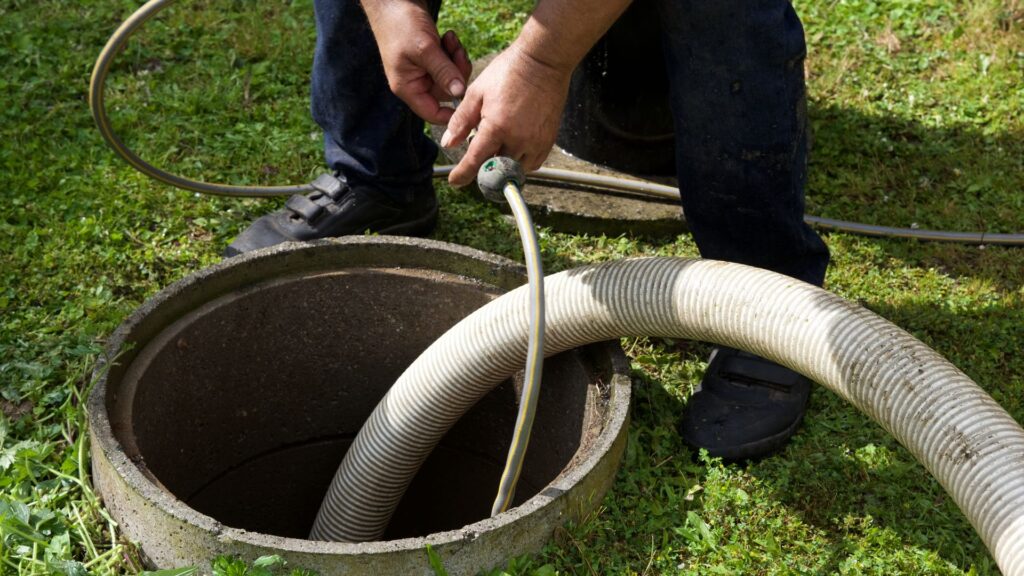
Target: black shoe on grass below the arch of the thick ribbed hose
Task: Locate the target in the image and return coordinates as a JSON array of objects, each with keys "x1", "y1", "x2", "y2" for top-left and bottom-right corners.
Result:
[{"x1": 679, "y1": 346, "x2": 811, "y2": 462}]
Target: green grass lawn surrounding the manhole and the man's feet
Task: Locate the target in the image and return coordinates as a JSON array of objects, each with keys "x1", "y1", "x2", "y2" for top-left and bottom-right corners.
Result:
[{"x1": 0, "y1": 0, "x2": 1024, "y2": 575}]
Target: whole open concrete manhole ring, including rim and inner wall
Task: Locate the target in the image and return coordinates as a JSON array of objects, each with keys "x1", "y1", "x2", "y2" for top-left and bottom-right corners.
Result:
[{"x1": 89, "y1": 237, "x2": 630, "y2": 574}]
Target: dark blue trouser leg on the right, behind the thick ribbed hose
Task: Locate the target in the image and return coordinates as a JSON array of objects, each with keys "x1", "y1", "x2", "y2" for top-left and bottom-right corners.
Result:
[{"x1": 655, "y1": 0, "x2": 828, "y2": 285}]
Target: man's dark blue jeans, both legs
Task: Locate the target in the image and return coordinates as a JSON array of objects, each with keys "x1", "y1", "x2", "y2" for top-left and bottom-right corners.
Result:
[{"x1": 312, "y1": 0, "x2": 828, "y2": 285}]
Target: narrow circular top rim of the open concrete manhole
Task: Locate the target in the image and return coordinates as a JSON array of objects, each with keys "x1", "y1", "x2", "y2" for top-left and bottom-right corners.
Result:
[{"x1": 88, "y1": 237, "x2": 631, "y2": 556}]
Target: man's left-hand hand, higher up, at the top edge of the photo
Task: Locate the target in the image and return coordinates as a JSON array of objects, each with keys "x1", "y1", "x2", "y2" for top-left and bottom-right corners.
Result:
[{"x1": 362, "y1": 0, "x2": 472, "y2": 124}]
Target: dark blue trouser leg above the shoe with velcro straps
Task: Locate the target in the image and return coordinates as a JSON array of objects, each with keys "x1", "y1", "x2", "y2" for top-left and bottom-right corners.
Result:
[{"x1": 311, "y1": 0, "x2": 440, "y2": 202}]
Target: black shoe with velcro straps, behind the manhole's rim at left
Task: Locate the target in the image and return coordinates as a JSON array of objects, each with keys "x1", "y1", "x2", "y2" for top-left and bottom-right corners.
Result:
[{"x1": 224, "y1": 174, "x2": 437, "y2": 256}]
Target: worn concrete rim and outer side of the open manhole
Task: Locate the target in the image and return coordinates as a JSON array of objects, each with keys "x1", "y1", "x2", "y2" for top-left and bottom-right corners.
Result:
[{"x1": 87, "y1": 237, "x2": 630, "y2": 574}]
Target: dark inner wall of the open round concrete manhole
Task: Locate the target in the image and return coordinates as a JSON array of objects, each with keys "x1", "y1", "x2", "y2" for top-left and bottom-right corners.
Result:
[{"x1": 94, "y1": 235, "x2": 628, "y2": 567}]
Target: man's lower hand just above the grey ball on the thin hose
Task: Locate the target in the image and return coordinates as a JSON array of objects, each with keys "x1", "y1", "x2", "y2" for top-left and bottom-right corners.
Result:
[{"x1": 441, "y1": 44, "x2": 572, "y2": 187}]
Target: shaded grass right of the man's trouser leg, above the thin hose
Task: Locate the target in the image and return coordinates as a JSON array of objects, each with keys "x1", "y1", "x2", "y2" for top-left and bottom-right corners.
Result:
[{"x1": 808, "y1": 102, "x2": 1024, "y2": 233}]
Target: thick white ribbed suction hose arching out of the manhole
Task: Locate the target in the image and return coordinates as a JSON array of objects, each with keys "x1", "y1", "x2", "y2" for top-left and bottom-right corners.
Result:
[{"x1": 311, "y1": 258, "x2": 1024, "y2": 576}]
